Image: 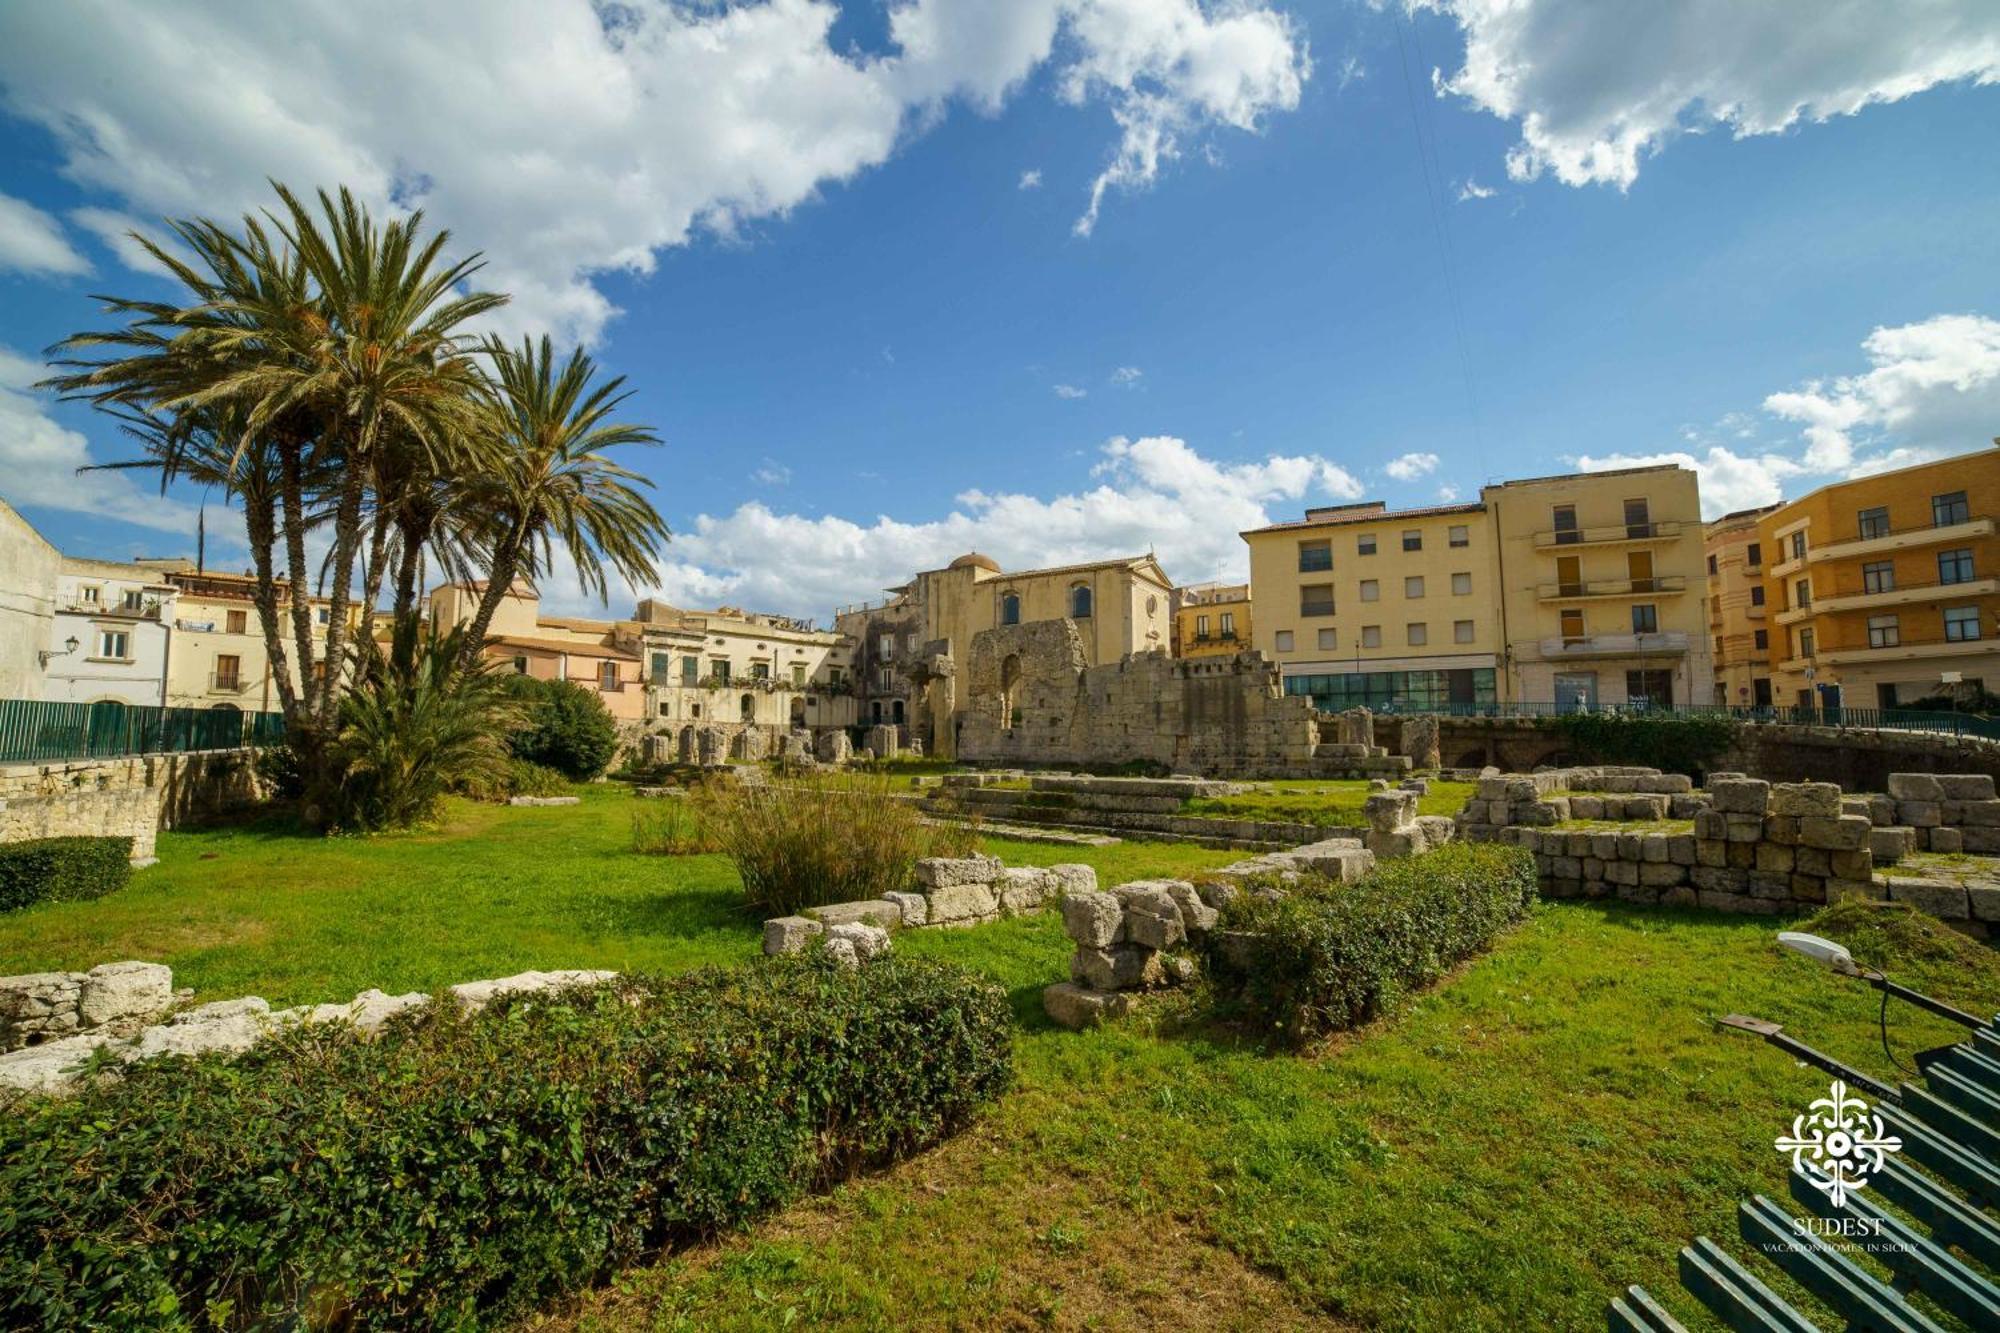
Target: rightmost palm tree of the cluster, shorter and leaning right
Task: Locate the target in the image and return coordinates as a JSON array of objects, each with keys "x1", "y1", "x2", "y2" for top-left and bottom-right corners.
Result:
[{"x1": 464, "y1": 336, "x2": 670, "y2": 654}]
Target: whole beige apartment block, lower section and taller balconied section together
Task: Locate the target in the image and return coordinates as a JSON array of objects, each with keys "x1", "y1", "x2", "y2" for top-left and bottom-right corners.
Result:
[{"x1": 1242, "y1": 466, "x2": 1714, "y2": 711}]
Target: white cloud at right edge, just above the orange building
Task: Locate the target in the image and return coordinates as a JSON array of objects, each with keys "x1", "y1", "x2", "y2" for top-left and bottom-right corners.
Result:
[{"x1": 1576, "y1": 314, "x2": 2000, "y2": 518}]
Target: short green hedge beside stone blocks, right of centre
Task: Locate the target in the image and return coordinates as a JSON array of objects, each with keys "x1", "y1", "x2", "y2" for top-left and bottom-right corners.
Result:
[{"x1": 1210, "y1": 843, "x2": 1534, "y2": 1045}]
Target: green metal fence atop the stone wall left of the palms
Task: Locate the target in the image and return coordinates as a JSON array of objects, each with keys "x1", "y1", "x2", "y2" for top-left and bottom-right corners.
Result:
[{"x1": 0, "y1": 699, "x2": 284, "y2": 765}]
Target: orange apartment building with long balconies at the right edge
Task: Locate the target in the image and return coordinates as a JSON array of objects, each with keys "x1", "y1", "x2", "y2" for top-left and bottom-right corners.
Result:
[{"x1": 1758, "y1": 448, "x2": 2000, "y2": 709}]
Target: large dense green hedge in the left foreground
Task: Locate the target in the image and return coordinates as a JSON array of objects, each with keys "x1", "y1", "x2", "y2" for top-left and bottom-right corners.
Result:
[{"x1": 0, "y1": 957, "x2": 1012, "y2": 1329}]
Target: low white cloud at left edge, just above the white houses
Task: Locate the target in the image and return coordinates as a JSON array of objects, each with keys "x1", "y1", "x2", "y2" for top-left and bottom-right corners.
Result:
[{"x1": 0, "y1": 346, "x2": 205, "y2": 534}]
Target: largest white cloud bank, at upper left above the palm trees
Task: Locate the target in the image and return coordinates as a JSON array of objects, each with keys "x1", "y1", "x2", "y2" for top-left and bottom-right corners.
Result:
[{"x1": 0, "y1": 0, "x2": 1310, "y2": 338}]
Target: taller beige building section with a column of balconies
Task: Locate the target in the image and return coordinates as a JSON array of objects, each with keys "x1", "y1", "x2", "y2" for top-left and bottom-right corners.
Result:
[{"x1": 1480, "y1": 464, "x2": 1716, "y2": 709}]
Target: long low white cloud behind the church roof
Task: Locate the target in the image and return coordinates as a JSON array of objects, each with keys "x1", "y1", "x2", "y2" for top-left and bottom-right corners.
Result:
[{"x1": 544, "y1": 436, "x2": 1362, "y2": 622}]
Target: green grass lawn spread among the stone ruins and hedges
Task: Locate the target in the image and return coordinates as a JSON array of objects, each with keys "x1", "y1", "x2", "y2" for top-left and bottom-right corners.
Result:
[{"x1": 0, "y1": 789, "x2": 2000, "y2": 1329}]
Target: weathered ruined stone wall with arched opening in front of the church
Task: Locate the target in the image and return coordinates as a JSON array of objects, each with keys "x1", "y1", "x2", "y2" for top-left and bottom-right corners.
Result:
[{"x1": 958, "y1": 620, "x2": 1318, "y2": 777}]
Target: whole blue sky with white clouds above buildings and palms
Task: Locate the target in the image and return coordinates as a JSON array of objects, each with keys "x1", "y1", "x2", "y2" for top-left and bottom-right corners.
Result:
[{"x1": 0, "y1": 0, "x2": 2000, "y2": 618}]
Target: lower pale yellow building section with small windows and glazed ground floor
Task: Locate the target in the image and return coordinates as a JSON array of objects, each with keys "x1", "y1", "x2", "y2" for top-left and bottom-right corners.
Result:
[{"x1": 1242, "y1": 500, "x2": 1502, "y2": 713}]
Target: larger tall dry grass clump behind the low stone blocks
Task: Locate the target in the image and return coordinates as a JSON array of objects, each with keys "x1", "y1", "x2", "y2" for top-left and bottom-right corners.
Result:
[{"x1": 688, "y1": 777, "x2": 938, "y2": 915}]
